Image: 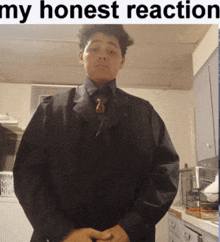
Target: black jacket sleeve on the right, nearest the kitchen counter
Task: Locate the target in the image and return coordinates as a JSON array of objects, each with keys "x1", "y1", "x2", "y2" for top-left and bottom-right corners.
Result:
[{"x1": 119, "y1": 108, "x2": 179, "y2": 242}]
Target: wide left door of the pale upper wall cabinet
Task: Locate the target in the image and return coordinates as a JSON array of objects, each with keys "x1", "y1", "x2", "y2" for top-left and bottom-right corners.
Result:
[{"x1": 194, "y1": 65, "x2": 215, "y2": 161}]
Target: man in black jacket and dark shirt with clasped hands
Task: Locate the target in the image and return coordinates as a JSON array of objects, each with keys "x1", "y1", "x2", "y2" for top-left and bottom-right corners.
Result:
[{"x1": 14, "y1": 25, "x2": 178, "y2": 242}]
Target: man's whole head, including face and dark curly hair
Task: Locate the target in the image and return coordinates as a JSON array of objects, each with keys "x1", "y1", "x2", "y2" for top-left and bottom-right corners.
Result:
[{"x1": 78, "y1": 25, "x2": 133, "y2": 86}]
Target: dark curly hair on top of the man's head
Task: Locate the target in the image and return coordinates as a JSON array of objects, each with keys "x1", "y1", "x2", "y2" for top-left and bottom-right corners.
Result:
[{"x1": 77, "y1": 24, "x2": 134, "y2": 56}]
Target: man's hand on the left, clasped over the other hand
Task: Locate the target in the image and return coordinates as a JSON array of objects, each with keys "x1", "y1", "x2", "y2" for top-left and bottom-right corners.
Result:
[{"x1": 62, "y1": 228, "x2": 111, "y2": 242}]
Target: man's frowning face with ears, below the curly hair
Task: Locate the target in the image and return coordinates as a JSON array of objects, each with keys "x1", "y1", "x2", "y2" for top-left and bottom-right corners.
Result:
[{"x1": 79, "y1": 32, "x2": 125, "y2": 86}]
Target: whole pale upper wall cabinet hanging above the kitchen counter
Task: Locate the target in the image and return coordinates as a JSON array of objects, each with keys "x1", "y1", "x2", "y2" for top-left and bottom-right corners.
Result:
[{"x1": 194, "y1": 50, "x2": 218, "y2": 161}]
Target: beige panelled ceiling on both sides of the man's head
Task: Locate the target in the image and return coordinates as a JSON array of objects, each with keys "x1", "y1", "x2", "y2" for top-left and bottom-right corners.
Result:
[{"x1": 0, "y1": 24, "x2": 211, "y2": 89}]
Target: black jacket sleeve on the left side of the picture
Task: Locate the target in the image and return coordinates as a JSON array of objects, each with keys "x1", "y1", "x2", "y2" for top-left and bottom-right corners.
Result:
[{"x1": 13, "y1": 97, "x2": 74, "y2": 241}]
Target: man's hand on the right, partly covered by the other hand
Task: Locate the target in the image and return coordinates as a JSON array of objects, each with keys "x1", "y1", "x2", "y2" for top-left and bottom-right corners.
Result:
[{"x1": 97, "y1": 225, "x2": 130, "y2": 242}]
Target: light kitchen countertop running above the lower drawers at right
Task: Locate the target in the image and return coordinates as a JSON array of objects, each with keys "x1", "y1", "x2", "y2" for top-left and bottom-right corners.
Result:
[{"x1": 169, "y1": 204, "x2": 219, "y2": 237}]
